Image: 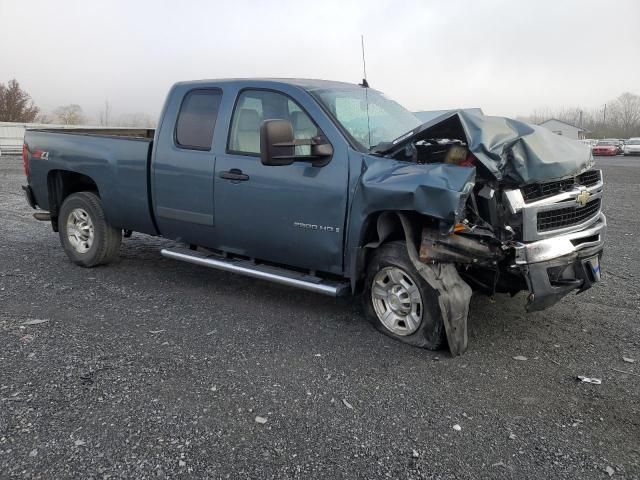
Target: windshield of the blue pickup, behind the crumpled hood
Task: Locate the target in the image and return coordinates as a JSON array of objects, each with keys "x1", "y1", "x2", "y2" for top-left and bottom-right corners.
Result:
[{"x1": 311, "y1": 87, "x2": 422, "y2": 150}]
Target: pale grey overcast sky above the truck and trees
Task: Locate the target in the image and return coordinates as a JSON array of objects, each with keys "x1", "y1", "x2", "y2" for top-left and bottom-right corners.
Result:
[{"x1": 0, "y1": 0, "x2": 640, "y2": 120}]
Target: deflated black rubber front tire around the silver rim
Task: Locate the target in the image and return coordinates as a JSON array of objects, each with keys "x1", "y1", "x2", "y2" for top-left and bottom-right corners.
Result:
[{"x1": 362, "y1": 242, "x2": 447, "y2": 350}]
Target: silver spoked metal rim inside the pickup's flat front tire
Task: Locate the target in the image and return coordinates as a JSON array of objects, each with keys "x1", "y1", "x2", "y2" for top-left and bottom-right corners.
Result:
[{"x1": 371, "y1": 267, "x2": 422, "y2": 336}]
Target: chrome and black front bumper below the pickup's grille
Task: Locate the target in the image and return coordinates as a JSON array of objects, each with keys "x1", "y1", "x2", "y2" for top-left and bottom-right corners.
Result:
[{"x1": 515, "y1": 213, "x2": 607, "y2": 312}]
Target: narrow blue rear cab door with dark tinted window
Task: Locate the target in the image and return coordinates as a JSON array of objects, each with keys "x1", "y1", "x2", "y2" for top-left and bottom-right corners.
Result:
[{"x1": 151, "y1": 86, "x2": 222, "y2": 246}]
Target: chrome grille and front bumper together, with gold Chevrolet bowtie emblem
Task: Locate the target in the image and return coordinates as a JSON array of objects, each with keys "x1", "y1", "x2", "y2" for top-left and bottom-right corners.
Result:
[{"x1": 504, "y1": 180, "x2": 607, "y2": 312}]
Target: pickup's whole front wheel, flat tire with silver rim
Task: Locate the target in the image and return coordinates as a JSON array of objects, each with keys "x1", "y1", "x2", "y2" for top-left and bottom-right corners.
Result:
[{"x1": 363, "y1": 242, "x2": 446, "y2": 350}]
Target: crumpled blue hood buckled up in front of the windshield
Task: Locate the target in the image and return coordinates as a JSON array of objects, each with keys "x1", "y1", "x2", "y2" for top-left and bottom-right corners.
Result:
[{"x1": 375, "y1": 110, "x2": 593, "y2": 186}]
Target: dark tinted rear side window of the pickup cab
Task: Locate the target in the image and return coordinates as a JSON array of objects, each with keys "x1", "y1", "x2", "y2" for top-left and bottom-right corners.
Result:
[{"x1": 174, "y1": 89, "x2": 222, "y2": 150}]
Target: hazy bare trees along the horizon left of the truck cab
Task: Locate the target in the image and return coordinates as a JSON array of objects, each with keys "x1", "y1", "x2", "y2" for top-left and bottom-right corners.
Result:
[{"x1": 0, "y1": 79, "x2": 155, "y2": 127}]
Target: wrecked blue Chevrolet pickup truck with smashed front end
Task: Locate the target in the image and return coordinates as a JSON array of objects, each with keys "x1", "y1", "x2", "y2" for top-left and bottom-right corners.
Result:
[{"x1": 23, "y1": 79, "x2": 606, "y2": 355}]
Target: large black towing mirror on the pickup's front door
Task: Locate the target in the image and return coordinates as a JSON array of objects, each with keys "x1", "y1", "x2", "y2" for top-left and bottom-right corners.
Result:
[{"x1": 260, "y1": 119, "x2": 333, "y2": 167}]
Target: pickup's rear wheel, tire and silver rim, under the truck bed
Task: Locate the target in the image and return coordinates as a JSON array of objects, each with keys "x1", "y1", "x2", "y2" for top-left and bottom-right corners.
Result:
[{"x1": 58, "y1": 192, "x2": 122, "y2": 267}]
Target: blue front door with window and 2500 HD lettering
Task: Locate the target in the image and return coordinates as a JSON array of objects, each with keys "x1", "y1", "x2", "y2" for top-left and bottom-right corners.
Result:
[{"x1": 214, "y1": 89, "x2": 348, "y2": 273}]
